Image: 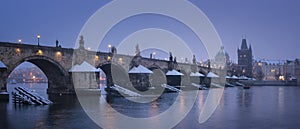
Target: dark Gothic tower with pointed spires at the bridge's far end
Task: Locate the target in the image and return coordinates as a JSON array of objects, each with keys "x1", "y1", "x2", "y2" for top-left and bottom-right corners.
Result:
[{"x1": 238, "y1": 38, "x2": 252, "y2": 77}]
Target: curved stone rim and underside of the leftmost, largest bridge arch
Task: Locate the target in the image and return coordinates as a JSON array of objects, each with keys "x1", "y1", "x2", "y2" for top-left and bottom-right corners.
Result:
[{"x1": 7, "y1": 55, "x2": 73, "y2": 93}]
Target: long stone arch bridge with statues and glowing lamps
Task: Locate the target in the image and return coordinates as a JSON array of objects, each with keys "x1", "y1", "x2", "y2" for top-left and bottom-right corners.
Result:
[{"x1": 0, "y1": 38, "x2": 212, "y2": 93}]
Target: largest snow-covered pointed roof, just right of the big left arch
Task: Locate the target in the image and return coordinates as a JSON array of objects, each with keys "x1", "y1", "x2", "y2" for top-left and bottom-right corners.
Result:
[{"x1": 69, "y1": 61, "x2": 100, "y2": 72}]
